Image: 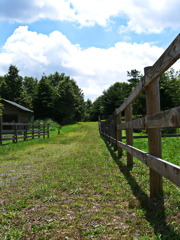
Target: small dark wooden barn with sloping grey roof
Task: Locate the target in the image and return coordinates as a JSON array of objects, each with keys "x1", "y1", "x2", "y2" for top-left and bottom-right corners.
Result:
[{"x1": 1, "y1": 99, "x2": 33, "y2": 123}]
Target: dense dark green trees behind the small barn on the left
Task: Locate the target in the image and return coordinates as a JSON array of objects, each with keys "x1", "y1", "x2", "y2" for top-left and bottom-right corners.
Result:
[{"x1": 0, "y1": 65, "x2": 85, "y2": 124}]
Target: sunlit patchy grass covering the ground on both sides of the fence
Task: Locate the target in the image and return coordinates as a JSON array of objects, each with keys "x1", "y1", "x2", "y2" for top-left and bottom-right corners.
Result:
[{"x1": 0, "y1": 123, "x2": 180, "y2": 240}]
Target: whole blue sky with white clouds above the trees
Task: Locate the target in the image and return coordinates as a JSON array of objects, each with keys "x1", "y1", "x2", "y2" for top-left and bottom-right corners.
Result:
[{"x1": 0, "y1": 0, "x2": 180, "y2": 100}]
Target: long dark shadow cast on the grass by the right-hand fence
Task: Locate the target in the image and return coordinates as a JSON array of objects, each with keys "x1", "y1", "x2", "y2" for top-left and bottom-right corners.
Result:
[{"x1": 102, "y1": 138, "x2": 180, "y2": 240}]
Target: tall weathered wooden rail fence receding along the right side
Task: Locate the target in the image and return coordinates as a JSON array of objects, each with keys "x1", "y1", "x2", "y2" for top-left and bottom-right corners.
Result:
[{"x1": 99, "y1": 34, "x2": 180, "y2": 196}]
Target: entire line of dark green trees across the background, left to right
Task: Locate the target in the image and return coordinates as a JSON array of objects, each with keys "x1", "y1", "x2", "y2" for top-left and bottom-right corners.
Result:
[{"x1": 0, "y1": 65, "x2": 180, "y2": 125}]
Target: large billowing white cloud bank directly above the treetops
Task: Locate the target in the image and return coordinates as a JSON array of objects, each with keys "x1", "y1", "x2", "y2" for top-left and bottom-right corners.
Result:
[{"x1": 0, "y1": 26, "x2": 163, "y2": 99}]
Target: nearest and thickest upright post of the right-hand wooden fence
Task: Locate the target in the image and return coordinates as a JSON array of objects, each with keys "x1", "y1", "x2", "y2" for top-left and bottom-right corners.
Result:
[{"x1": 144, "y1": 67, "x2": 163, "y2": 197}]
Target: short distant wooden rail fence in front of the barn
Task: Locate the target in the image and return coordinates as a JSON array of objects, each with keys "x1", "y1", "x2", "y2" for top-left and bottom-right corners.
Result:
[{"x1": 0, "y1": 118, "x2": 49, "y2": 145}]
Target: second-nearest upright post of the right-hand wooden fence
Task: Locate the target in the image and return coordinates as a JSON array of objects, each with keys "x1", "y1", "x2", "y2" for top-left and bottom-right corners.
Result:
[{"x1": 125, "y1": 98, "x2": 133, "y2": 166}]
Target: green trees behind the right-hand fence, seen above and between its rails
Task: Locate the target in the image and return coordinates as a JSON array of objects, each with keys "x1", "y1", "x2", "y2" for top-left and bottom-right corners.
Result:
[{"x1": 90, "y1": 68, "x2": 180, "y2": 120}]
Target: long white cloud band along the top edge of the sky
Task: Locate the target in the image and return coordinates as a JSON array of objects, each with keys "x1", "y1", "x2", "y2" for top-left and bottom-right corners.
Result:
[{"x1": 0, "y1": 0, "x2": 180, "y2": 33}]
